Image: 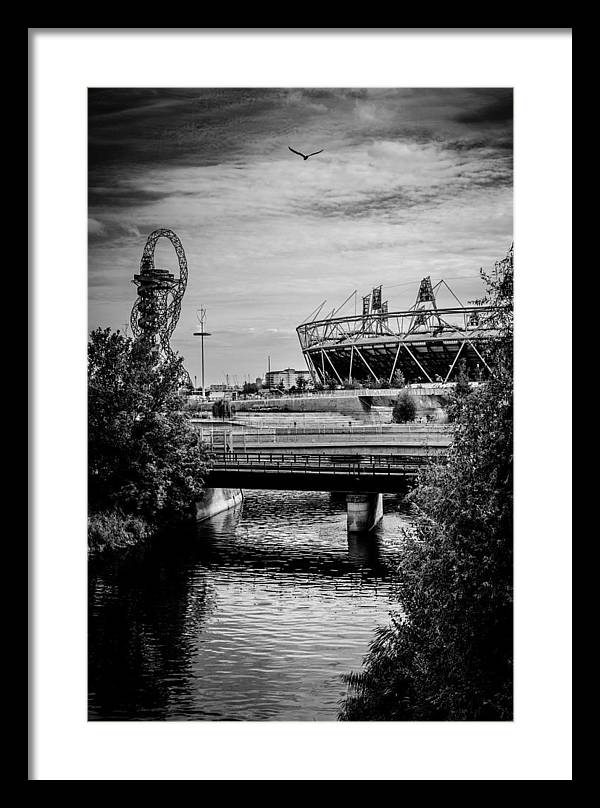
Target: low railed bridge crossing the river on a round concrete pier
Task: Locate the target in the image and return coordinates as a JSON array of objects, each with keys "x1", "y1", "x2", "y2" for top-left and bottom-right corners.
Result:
[{"x1": 196, "y1": 424, "x2": 452, "y2": 533}]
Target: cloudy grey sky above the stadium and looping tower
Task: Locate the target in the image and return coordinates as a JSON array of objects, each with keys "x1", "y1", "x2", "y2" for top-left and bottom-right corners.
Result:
[{"x1": 89, "y1": 89, "x2": 512, "y2": 384}]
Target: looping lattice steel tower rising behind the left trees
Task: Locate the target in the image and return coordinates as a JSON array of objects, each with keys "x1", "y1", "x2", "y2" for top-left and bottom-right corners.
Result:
[{"x1": 130, "y1": 227, "x2": 189, "y2": 380}]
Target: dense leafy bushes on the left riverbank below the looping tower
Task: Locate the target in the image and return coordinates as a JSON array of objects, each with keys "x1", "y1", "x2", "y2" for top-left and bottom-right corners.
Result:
[{"x1": 88, "y1": 328, "x2": 208, "y2": 554}]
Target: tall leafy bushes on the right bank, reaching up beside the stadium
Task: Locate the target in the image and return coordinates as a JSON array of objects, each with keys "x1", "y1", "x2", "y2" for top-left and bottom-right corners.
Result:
[{"x1": 340, "y1": 248, "x2": 513, "y2": 721}]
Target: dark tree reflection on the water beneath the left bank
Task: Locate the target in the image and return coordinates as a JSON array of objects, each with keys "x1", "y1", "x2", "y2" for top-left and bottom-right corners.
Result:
[{"x1": 88, "y1": 552, "x2": 214, "y2": 719}]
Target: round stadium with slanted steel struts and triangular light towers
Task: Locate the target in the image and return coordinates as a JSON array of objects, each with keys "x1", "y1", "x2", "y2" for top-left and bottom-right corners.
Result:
[{"x1": 296, "y1": 277, "x2": 504, "y2": 386}]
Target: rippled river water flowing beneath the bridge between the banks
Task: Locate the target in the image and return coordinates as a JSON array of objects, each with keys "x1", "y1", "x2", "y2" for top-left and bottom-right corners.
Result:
[{"x1": 89, "y1": 491, "x2": 409, "y2": 721}]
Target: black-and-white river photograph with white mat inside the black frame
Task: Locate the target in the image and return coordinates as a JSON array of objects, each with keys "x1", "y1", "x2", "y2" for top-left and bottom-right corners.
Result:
[{"x1": 29, "y1": 29, "x2": 571, "y2": 779}]
